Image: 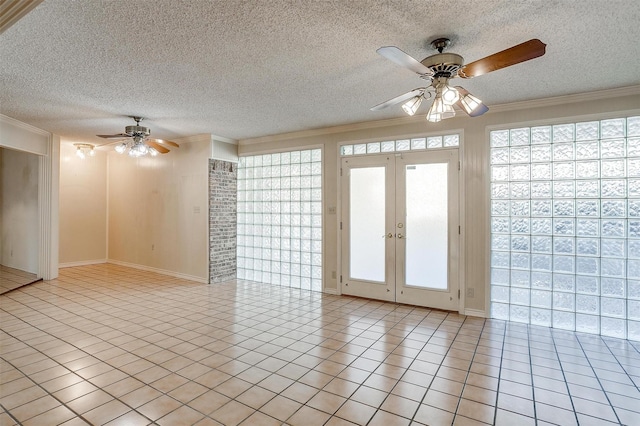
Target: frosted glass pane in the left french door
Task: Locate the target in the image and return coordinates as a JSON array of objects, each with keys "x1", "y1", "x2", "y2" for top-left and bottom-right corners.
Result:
[{"x1": 349, "y1": 167, "x2": 385, "y2": 282}]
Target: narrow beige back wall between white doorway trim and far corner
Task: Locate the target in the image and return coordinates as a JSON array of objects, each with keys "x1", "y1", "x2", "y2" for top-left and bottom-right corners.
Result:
[{"x1": 60, "y1": 142, "x2": 107, "y2": 266}]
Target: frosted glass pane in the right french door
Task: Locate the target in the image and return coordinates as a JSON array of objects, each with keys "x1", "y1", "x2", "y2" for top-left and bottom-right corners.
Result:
[{"x1": 408, "y1": 163, "x2": 448, "y2": 290}]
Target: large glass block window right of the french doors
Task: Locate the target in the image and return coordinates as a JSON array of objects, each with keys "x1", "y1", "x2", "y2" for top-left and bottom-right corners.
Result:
[{"x1": 490, "y1": 117, "x2": 640, "y2": 340}]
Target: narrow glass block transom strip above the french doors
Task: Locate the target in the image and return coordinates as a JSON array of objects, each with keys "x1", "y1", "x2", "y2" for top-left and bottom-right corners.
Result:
[{"x1": 340, "y1": 134, "x2": 460, "y2": 157}]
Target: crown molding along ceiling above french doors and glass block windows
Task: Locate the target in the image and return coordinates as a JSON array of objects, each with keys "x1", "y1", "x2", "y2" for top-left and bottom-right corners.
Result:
[{"x1": 237, "y1": 85, "x2": 640, "y2": 145}]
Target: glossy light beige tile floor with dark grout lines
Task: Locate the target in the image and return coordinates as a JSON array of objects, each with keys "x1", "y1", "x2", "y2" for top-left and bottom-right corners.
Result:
[{"x1": 0, "y1": 264, "x2": 640, "y2": 426}]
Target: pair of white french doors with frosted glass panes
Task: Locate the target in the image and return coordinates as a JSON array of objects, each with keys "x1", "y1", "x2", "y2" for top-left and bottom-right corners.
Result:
[{"x1": 341, "y1": 149, "x2": 459, "y2": 310}]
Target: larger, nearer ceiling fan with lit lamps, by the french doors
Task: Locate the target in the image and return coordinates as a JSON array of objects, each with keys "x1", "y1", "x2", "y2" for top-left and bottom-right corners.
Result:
[{"x1": 371, "y1": 38, "x2": 546, "y2": 123}]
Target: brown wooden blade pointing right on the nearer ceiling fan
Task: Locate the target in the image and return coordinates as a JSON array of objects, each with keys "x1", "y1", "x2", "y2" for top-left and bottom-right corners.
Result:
[{"x1": 458, "y1": 39, "x2": 547, "y2": 78}]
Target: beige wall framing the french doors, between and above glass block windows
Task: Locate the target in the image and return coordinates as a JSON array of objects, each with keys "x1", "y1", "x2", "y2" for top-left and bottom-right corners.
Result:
[{"x1": 239, "y1": 87, "x2": 640, "y2": 312}]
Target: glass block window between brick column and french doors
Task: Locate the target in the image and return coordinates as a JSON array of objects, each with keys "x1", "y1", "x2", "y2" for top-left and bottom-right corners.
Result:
[{"x1": 237, "y1": 149, "x2": 322, "y2": 291}]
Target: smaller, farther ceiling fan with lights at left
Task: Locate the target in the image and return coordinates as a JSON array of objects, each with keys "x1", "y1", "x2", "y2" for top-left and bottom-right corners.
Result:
[{"x1": 97, "y1": 116, "x2": 180, "y2": 157}]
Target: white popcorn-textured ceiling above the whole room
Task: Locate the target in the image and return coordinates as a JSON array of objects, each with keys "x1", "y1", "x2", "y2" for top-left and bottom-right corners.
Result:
[{"x1": 0, "y1": 0, "x2": 640, "y2": 142}]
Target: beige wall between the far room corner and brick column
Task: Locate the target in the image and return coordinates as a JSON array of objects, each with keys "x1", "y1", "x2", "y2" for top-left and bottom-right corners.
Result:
[{"x1": 107, "y1": 139, "x2": 211, "y2": 282}]
